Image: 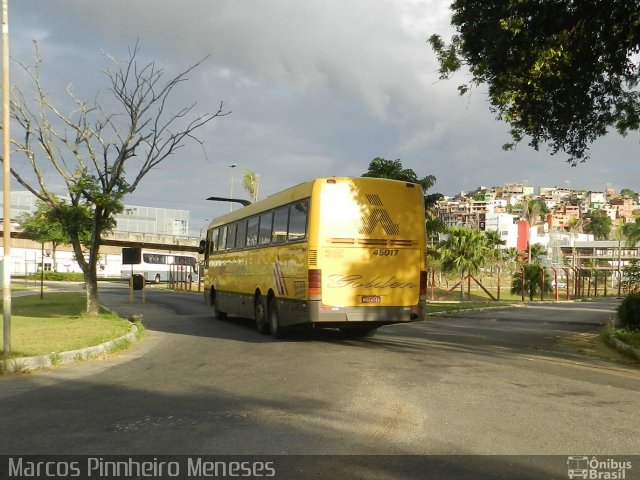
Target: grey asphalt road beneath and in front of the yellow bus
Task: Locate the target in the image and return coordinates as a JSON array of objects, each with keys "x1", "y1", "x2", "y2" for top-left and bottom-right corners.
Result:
[{"x1": 0, "y1": 286, "x2": 640, "y2": 478}]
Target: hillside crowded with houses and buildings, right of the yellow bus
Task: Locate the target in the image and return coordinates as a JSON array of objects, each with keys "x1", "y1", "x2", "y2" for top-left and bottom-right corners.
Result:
[{"x1": 435, "y1": 183, "x2": 640, "y2": 280}]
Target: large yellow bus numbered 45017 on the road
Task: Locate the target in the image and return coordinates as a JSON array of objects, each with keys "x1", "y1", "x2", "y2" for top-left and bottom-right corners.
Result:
[{"x1": 200, "y1": 177, "x2": 427, "y2": 338}]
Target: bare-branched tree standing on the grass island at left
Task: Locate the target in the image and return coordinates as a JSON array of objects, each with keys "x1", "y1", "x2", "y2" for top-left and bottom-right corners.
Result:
[{"x1": 4, "y1": 42, "x2": 230, "y2": 315}]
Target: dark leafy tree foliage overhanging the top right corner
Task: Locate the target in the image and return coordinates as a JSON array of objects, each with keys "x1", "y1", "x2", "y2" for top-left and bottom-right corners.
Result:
[{"x1": 429, "y1": 0, "x2": 640, "y2": 165}]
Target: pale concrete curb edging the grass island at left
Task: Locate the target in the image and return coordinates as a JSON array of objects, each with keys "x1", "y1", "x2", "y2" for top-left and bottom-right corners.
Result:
[{"x1": 0, "y1": 324, "x2": 138, "y2": 374}]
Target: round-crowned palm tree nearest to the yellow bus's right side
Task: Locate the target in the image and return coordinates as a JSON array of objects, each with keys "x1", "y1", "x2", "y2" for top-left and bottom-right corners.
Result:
[{"x1": 439, "y1": 227, "x2": 490, "y2": 301}]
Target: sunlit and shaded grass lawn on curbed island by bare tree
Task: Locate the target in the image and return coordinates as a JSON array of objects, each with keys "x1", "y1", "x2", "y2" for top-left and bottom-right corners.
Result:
[{"x1": 0, "y1": 293, "x2": 131, "y2": 358}]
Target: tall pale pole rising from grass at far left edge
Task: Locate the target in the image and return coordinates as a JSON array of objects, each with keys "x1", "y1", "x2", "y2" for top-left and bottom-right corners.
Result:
[{"x1": 2, "y1": 0, "x2": 11, "y2": 356}]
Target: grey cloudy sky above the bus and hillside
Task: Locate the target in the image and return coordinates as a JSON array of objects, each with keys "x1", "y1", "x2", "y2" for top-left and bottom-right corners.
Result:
[{"x1": 8, "y1": 0, "x2": 640, "y2": 233}]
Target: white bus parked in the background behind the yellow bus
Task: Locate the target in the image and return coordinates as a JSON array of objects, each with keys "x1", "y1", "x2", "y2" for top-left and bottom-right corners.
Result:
[{"x1": 120, "y1": 250, "x2": 198, "y2": 283}]
